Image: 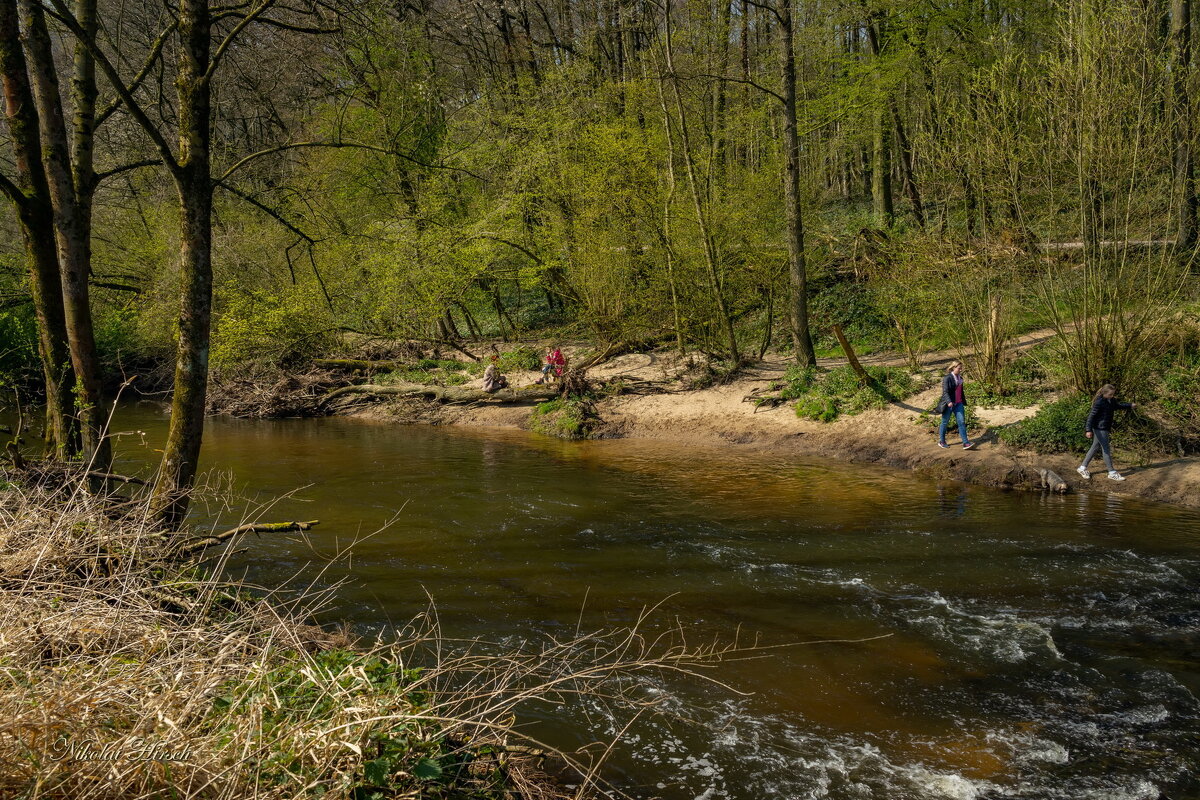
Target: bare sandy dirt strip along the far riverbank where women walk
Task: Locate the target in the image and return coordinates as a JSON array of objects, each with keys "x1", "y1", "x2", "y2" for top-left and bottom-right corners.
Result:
[{"x1": 355, "y1": 329, "x2": 1200, "y2": 507}]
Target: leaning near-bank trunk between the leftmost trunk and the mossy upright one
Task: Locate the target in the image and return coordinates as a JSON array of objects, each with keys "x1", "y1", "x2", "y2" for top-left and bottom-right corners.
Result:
[{"x1": 19, "y1": 0, "x2": 112, "y2": 471}]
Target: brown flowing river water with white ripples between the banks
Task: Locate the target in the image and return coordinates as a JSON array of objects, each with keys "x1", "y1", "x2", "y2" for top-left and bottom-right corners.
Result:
[{"x1": 100, "y1": 404, "x2": 1200, "y2": 800}]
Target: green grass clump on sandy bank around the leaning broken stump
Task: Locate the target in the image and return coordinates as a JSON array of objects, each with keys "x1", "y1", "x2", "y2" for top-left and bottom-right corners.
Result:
[{"x1": 779, "y1": 366, "x2": 924, "y2": 422}]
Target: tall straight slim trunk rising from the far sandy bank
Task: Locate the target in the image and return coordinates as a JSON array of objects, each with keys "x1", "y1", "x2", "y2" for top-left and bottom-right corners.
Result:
[{"x1": 779, "y1": 0, "x2": 817, "y2": 367}]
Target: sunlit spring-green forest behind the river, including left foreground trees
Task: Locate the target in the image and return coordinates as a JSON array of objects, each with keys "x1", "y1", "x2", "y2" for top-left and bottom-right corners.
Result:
[{"x1": 0, "y1": 0, "x2": 1200, "y2": 519}]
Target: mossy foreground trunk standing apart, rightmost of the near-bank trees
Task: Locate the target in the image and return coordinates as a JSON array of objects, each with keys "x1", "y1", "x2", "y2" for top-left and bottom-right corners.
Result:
[{"x1": 155, "y1": 0, "x2": 212, "y2": 528}]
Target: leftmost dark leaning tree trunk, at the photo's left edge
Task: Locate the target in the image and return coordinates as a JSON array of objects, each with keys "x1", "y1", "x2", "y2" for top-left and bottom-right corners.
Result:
[{"x1": 0, "y1": 0, "x2": 79, "y2": 458}]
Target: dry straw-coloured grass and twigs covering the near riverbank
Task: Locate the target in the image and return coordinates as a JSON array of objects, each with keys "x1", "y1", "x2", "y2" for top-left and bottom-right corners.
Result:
[{"x1": 0, "y1": 482, "x2": 745, "y2": 800}]
